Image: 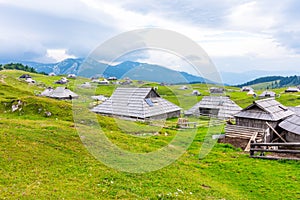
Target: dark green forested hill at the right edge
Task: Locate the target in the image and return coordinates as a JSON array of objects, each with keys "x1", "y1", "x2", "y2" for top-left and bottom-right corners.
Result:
[{"x1": 236, "y1": 75, "x2": 300, "y2": 88}]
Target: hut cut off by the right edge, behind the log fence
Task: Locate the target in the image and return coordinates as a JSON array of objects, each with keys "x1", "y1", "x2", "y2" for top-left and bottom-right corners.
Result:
[{"x1": 278, "y1": 115, "x2": 300, "y2": 142}]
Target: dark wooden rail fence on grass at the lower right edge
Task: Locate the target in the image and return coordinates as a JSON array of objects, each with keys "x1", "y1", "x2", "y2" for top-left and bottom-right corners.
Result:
[{"x1": 250, "y1": 141, "x2": 300, "y2": 160}]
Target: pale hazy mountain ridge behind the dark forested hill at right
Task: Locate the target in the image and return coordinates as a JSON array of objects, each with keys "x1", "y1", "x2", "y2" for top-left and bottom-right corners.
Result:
[{"x1": 220, "y1": 70, "x2": 300, "y2": 85}]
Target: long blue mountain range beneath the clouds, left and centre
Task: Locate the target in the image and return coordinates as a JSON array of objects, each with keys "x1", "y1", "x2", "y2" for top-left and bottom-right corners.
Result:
[{"x1": 1, "y1": 58, "x2": 214, "y2": 84}]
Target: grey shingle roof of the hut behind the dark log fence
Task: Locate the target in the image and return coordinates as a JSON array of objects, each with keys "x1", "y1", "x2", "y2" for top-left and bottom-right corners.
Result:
[{"x1": 234, "y1": 98, "x2": 294, "y2": 121}]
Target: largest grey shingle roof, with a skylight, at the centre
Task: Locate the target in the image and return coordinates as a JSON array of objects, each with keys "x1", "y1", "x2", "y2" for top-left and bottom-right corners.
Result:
[{"x1": 92, "y1": 87, "x2": 181, "y2": 119}]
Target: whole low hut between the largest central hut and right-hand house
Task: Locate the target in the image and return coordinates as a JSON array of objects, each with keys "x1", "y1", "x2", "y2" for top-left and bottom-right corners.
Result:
[{"x1": 185, "y1": 96, "x2": 242, "y2": 118}]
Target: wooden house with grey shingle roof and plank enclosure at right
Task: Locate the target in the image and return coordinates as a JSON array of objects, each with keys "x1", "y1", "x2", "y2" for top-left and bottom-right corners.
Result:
[{"x1": 225, "y1": 98, "x2": 294, "y2": 148}]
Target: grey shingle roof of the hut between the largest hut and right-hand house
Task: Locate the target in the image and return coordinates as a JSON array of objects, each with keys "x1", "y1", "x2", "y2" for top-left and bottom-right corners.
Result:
[{"x1": 186, "y1": 96, "x2": 242, "y2": 118}]
